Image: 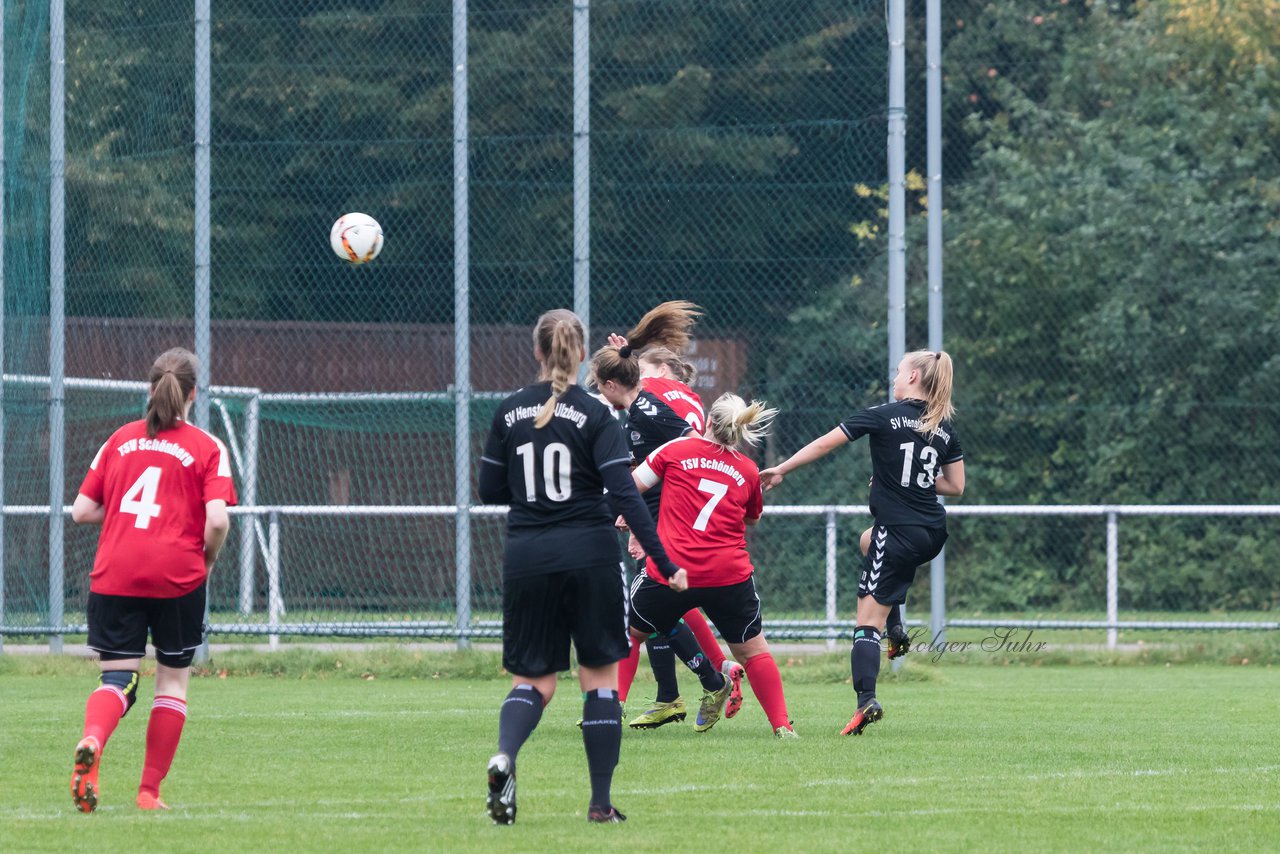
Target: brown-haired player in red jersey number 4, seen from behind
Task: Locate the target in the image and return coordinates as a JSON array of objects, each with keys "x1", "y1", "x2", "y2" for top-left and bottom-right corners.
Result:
[{"x1": 72, "y1": 347, "x2": 236, "y2": 813}]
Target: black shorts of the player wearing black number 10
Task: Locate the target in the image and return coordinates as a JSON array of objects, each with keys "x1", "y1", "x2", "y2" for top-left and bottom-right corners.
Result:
[{"x1": 502, "y1": 563, "x2": 631, "y2": 677}]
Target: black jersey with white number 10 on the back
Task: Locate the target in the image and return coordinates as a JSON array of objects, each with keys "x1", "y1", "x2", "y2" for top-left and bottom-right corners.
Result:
[{"x1": 480, "y1": 383, "x2": 630, "y2": 576}]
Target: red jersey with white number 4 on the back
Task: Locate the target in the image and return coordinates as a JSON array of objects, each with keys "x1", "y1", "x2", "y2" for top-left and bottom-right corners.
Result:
[{"x1": 79, "y1": 421, "x2": 236, "y2": 599}]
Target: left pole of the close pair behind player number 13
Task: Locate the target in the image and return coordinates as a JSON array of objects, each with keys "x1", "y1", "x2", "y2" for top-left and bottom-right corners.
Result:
[{"x1": 887, "y1": 0, "x2": 906, "y2": 671}]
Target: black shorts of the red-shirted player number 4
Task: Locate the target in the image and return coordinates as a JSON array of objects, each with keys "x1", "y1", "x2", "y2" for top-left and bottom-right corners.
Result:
[{"x1": 88, "y1": 584, "x2": 205, "y2": 667}]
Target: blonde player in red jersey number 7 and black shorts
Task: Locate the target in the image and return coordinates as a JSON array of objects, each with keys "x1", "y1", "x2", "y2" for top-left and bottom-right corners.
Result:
[{"x1": 631, "y1": 393, "x2": 795, "y2": 739}]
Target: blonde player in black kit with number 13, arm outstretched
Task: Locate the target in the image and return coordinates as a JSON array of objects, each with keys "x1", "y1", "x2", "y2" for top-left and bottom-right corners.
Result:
[{"x1": 760, "y1": 350, "x2": 964, "y2": 735}]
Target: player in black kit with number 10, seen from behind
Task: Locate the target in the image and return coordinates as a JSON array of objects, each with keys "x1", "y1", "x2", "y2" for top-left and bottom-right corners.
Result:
[{"x1": 479, "y1": 309, "x2": 687, "y2": 825}]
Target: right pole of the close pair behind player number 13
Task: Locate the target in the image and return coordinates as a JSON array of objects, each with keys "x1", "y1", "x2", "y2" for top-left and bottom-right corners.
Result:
[{"x1": 924, "y1": 0, "x2": 947, "y2": 641}]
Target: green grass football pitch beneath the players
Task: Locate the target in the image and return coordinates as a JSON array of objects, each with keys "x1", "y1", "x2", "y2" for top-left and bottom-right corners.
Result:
[{"x1": 0, "y1": 652, "x2": 1280, "y2": 854}]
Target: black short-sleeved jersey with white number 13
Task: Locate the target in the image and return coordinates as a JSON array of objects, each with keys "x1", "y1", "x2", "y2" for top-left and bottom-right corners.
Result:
[{"x1": 840, "y1": 398, "x2": 964, "y2": 526}]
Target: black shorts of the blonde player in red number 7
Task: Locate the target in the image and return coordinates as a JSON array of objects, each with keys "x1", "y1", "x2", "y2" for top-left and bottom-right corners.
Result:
[{"x1": 630, "y1": 575, "x2": 763, "y2": 644}]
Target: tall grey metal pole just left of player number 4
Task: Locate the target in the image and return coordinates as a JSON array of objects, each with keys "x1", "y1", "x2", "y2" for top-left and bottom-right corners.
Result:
[{"x1": 49, "y1": 0, "x2": 67, "y2": 653}]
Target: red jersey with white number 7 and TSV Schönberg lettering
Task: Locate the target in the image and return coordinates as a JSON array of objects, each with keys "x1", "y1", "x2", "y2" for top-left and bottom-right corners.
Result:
[{"x1": 635, "y1": 435, "x2": 764, "y2": 588}]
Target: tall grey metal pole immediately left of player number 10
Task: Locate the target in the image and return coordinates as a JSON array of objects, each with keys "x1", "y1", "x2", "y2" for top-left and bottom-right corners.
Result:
[{"x1": 453, "y1": 0, "x2": 471, "y2": 649}]
